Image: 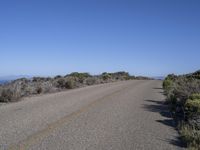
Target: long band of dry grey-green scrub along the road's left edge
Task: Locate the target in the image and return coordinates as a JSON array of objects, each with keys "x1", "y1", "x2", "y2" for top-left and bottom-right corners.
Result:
[{"x1": 0, "y1": 72, "x2": 149, "y2": 102}]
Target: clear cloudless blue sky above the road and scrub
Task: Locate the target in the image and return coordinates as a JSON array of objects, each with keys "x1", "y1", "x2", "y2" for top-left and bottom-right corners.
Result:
[{"x1": 0, "y1": 0, "x2": 200, "y2": 76}]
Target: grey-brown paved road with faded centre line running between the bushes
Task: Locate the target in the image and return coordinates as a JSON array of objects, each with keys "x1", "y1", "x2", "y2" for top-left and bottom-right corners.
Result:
[{"x1": 0, "y1": 80, "x2": 184, "y2": 150}]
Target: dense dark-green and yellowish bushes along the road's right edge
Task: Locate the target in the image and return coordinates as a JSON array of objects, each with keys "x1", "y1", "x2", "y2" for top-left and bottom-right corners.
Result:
[{"x1": 163, "y1": 70, "x2": 200, "y2": 150}]
